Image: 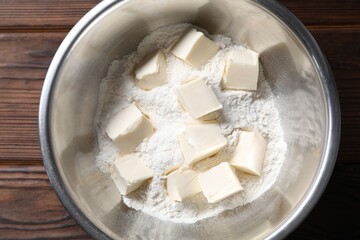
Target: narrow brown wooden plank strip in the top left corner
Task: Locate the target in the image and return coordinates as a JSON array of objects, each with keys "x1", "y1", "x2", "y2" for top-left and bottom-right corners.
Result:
[{"x1": 0, "y1": 0, "x2": 100, "y2": 32}]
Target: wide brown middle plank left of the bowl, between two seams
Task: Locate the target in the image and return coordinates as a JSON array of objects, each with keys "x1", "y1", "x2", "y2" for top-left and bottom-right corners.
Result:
[{"x1": 0, "y1": 32, "x2": 66, "y2": 165}]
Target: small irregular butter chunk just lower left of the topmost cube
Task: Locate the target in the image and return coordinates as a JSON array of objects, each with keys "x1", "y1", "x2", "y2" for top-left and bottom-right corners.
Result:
[{"x1": 135, "y1": 50, "x2": 166, "y2": 90}]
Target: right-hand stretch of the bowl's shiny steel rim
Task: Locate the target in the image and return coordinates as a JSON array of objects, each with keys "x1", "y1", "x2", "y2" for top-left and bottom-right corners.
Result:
[{"x1": 256, "y1": 0, "x2": 341, "y2": 239}]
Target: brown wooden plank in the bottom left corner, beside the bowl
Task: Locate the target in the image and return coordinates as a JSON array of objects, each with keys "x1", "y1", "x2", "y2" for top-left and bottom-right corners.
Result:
[{"x1": 0, "y1": 165, "x2": 90, "y2": 239}]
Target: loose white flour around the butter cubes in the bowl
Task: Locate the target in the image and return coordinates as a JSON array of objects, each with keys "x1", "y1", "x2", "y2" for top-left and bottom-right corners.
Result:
[{"x1": 95, "y1": 24, "x2": 286, "y2": 223}]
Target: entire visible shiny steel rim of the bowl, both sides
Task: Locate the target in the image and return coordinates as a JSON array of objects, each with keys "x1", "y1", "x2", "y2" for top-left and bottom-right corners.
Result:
[{"x1": 38, "y1": 0, "x2": 341, "y2": 239}]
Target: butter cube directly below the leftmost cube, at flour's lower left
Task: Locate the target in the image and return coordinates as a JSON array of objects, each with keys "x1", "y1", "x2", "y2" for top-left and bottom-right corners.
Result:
[{"x1": 111, "y1": 154, "x2": 154, "y2": 195}]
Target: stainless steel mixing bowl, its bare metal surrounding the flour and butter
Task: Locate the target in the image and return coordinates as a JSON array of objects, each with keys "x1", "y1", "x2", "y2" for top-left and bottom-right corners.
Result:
[{"x1": 39, "y1": 0, "x2": 340, "y2": 239}]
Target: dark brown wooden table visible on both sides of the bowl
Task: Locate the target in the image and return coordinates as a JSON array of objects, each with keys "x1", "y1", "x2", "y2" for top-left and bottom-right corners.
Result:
[{"x1": 0, "y1": 0, "x2": 360, "y2": 239}]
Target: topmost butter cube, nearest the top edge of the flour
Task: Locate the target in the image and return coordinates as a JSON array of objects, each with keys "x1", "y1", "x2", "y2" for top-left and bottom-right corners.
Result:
[{"x1": 171, "y1": 29, "x2": 219, "y2": 68}]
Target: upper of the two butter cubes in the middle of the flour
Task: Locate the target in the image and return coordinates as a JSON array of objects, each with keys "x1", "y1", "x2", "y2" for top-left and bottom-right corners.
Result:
[{"x1": 175, "y1": 78, "x2": 222, "y2": 120}]
